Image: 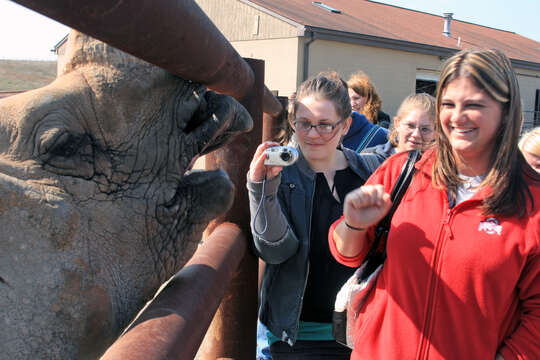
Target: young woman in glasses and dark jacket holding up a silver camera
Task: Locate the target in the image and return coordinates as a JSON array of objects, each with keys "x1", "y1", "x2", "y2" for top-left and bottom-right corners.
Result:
[{"x1": 247, "y1": 72, "x2": 380, "y2": 360}]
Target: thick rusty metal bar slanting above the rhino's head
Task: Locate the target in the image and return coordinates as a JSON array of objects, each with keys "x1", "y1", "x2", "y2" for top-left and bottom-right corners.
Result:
[{"x1": 14, "y1": 0, "x2": 281, "y2": 115}]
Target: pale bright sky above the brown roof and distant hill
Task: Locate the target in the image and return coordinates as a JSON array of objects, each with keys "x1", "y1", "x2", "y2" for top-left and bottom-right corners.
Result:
[{"x1": 0, "y1": 0, "x2": 540, "y2": 60}]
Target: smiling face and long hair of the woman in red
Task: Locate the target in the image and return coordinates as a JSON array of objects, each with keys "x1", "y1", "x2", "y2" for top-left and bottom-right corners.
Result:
[{"x1": 434, "y1": 51, "x2": 527, "y2": 215}]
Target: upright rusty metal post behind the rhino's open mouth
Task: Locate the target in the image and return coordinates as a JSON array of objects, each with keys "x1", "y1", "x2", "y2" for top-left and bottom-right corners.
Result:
[{"x1": 199, "y1": 59, "x2": 264, "y2": 360}]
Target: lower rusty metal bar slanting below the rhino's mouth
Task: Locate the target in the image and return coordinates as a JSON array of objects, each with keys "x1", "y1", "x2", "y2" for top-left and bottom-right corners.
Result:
[{"x1": 101, "y1": 223, "x2": 246, "y2": 360}]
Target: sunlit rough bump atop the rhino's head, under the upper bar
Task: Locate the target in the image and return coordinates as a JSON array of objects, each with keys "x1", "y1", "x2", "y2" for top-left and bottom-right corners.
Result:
[{"x1": 58, "y1": 30, "x2": 148, "y2": 77}]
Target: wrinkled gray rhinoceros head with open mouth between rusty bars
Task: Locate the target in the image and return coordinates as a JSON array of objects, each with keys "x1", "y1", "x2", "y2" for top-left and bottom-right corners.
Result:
[{"x1": 0, "y1": 32, "x2": 251, "y2": 359}]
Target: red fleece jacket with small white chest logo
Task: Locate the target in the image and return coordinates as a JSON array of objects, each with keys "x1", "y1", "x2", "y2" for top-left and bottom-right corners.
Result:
[{"x1": 329, "y1": 151, "x2": 540, "y2": 360}]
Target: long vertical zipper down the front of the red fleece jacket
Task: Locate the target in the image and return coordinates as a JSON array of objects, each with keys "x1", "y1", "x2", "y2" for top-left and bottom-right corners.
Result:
[{"x1": 417, "y1": 209, "x2": 454, "y2": 359}]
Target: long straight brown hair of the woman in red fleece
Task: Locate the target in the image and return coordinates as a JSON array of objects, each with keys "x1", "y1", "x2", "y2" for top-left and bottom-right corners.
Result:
[{"x1": 433, "y1": 50, "x2": 537, "y2": 217}]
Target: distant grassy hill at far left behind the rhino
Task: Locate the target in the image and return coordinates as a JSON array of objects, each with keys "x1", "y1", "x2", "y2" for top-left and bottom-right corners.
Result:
[{"x1": 0, "y1": 60, "x2": 56, "y2": 91}]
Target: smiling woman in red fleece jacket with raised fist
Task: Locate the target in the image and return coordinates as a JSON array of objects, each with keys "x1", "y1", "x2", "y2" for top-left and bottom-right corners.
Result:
[{"x1": 329, "y1": 50, "x2": 540, "y2": 360}]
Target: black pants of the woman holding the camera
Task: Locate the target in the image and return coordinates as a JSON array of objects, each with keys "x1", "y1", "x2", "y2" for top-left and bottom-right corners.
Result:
[{"x1": 270, "y1": 340, "x2": 351, "y2": 360}]
